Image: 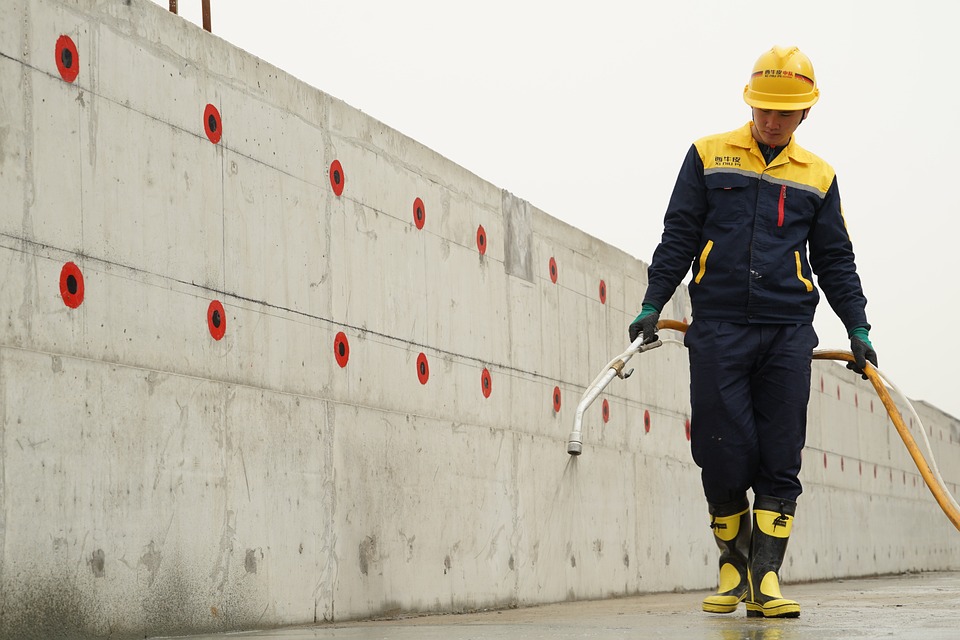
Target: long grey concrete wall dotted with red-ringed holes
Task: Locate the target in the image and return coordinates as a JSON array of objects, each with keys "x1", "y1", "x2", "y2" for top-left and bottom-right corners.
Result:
[{"x1": 0, "y1": 0, "x2": 960, "y2": 638}]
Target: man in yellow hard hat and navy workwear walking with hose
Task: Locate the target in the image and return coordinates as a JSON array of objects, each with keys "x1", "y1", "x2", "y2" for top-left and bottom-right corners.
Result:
[{"x1": 629, "y1": 47, "x2": 877, "y2": 618}]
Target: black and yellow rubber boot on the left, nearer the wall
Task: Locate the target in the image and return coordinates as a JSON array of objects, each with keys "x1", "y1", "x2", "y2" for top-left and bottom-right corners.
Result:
[{"x1": 703, "y1": 496, "x2": 750, "y2": 613}]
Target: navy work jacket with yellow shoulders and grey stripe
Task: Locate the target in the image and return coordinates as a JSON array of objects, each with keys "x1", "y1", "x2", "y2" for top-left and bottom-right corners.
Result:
[{"x1": 644, "y1": 123, "x2": 870, "y2": 333}]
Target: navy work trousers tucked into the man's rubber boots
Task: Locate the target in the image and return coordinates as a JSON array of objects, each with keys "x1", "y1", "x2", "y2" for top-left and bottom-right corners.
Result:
[{"x1": 684, "y1": 318, "x2": 818, "y2": 504}]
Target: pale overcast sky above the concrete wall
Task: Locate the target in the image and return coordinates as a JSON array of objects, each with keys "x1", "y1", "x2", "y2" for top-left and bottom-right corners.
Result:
[{"x1": 153, "y1": 0, "x2": 960, "y2": 417}]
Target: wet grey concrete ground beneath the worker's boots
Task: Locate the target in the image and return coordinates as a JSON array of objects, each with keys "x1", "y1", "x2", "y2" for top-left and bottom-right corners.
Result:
[{"x1": 158, "y1": 572, "x2": 960, "y2": 640}]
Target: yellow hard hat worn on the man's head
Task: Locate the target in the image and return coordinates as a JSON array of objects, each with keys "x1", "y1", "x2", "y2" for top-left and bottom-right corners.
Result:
[{"x1": 743, "y1": 47, "x2": 820, "y2": 111}]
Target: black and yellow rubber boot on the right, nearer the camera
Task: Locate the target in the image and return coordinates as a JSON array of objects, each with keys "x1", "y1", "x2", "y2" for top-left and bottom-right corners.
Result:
[{"x1": 747, "y1": 496, "x2": 800, "y2": 618}]
